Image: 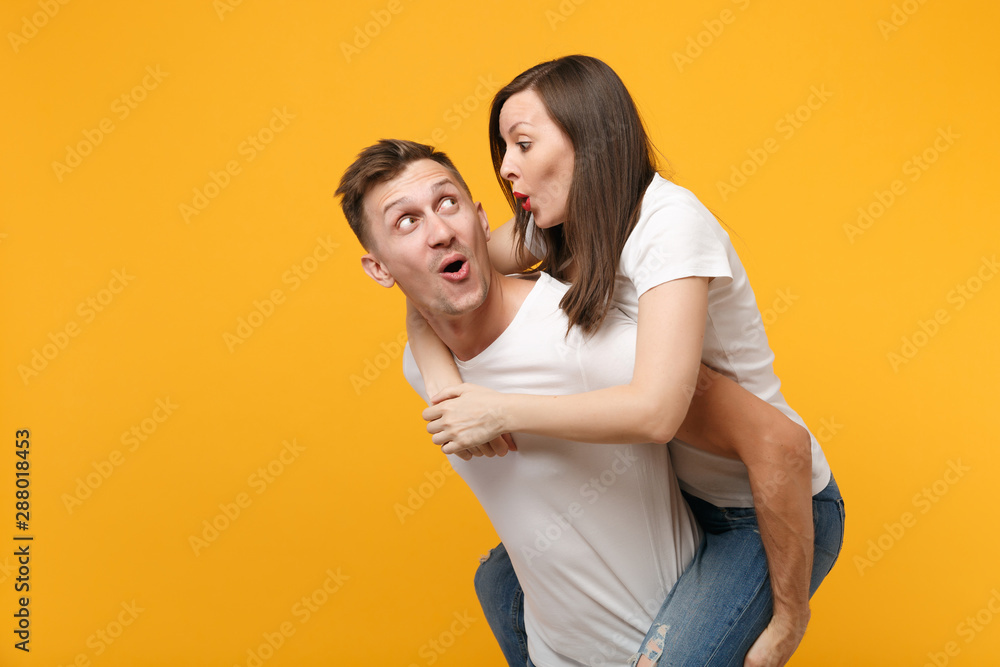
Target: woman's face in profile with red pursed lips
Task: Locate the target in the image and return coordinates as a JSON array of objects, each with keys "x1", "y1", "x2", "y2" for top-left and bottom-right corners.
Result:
[{"x1": 500, "y1": 89, "x2": 574, "y2": 229}]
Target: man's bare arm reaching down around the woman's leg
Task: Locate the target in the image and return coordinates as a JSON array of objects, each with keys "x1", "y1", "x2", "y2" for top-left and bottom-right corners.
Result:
[{"x1": 677, "y1": 365, "x2": 813, "y2": 667}]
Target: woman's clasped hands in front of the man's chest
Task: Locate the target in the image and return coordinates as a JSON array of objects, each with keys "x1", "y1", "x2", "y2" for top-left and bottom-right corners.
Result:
[{"x1": 423, "y1": 383, "x2": 516, "y2": 456}]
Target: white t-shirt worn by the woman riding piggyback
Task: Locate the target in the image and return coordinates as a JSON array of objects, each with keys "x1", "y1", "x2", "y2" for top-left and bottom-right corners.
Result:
[{"x1": 526, "y1": 174, "x2": 830, "y2": 507}]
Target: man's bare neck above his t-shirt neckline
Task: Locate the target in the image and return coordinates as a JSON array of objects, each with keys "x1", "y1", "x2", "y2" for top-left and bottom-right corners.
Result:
[{"x1": 423, "y1": 271, "x2": 534, "y2": 361}]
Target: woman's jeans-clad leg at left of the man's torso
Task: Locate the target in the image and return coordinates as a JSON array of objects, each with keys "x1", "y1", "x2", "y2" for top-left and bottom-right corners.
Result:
[{"x1": 474, "y1": 543, "x2": 531, "y2": 667}]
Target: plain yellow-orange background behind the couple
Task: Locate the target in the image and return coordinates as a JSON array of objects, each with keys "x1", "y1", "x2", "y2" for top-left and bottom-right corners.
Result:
[{"x1": 0, "y1": 0, "x2": 1000, "y2": 666}]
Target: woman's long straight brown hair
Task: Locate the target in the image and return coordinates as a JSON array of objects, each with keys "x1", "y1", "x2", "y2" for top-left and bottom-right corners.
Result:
[{"x1": 490, "y1": 56, "x2": 656, "y2": 333}]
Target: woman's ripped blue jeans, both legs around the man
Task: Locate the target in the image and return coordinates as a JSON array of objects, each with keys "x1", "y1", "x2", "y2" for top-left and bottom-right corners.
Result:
[{"x1": 475, "y1": 478, "x2": 844, "y2": 667}]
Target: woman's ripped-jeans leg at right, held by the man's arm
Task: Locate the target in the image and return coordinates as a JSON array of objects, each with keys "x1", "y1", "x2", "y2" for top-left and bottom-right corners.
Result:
[{"x1": 633, "y1": 479, "x2": 844, "y2": 667}]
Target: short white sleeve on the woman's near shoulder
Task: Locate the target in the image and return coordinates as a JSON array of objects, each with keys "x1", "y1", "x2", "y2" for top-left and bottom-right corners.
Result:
[{"x1": 620, "y1": 186, "x2": 733, "y2": 296}]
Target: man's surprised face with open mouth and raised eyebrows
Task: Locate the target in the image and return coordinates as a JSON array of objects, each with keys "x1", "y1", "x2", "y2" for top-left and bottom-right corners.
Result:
[{"x1": 361, "y1": 160, "x2": 490, "y2": 316}]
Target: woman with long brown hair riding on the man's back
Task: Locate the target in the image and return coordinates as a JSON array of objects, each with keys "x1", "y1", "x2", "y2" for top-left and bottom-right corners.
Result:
[{"x1": 408, "y1": 56, "x2": 843, "y2": 665}]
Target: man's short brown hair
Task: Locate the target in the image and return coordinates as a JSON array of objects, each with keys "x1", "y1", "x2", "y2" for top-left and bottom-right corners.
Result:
[{"x1": 336, "y1": 139, "x2": 472, "y2": 250}]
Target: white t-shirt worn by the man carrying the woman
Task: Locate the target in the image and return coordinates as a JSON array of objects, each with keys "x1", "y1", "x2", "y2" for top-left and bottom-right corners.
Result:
[{"x1": 403, "y1": 273, "x2": 701, "y2": 667}]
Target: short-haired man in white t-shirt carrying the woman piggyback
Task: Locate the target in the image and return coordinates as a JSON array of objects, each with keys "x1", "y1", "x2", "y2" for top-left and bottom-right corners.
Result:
[{"x1": 338, "y1": 141, "x2": 828, "y2": 666}]
